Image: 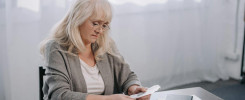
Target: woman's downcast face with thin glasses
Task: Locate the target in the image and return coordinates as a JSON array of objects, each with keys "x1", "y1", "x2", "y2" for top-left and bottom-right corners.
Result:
[{"x1": 79, "y1": 17, "x2": 109, "y2": 45}]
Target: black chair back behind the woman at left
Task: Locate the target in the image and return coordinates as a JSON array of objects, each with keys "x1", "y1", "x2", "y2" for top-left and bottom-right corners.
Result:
[{"x1": 39, "y1": 66, "x2": 45, "y2": 100}]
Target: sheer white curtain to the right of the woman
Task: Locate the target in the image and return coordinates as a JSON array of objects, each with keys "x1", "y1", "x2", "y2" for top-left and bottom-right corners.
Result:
[{"x1": 111, "y1": 0, "x2": 244, "y2": 89}]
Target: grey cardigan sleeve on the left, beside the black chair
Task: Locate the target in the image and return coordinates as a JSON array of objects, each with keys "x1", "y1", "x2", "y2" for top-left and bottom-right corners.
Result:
[{"x1": 43, "y1": 43, "x2": 88, "y2": 100}]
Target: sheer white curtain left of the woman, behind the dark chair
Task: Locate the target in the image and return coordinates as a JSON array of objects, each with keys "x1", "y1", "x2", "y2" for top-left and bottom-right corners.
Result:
[{"x1": 0, "y1": 0, "x2": 71, "y2": 100}]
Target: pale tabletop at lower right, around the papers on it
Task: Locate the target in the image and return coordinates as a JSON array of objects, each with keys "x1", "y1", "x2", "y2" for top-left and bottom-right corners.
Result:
[{"x1": 150, "y1": 87, "x2": 223, "y2": 100}]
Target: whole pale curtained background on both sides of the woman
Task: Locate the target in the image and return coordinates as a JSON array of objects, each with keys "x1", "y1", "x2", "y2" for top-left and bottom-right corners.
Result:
[{"x1": 0, "y1": 0, "x2": 245, "y2": 100}]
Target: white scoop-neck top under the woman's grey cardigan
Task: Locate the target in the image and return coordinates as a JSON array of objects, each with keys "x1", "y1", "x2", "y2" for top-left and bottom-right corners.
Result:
[{"x1": 80, "y1": 59, "x2": 105, "y2": 94}]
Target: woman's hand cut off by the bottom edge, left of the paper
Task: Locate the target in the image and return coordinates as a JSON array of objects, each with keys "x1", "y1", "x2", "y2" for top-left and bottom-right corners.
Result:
[{"x1": 106, "y1": 94, "x2": 135, "y2": 100}]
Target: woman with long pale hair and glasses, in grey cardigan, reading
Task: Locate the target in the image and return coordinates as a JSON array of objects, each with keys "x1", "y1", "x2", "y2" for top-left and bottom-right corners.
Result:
[{"x1": 40, "y1": 0, "x2": 150, "y2": 100}]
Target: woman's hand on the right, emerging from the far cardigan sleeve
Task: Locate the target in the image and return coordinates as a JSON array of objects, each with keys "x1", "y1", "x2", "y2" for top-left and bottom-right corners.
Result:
[{"x1": 128, "y1": 85, "x2": 151, "y2": 100}]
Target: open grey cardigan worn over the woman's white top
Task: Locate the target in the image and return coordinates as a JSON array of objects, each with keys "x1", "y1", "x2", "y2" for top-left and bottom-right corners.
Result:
[{"x1": 43, "y1": 41, "x2": 140, "y2": 100}]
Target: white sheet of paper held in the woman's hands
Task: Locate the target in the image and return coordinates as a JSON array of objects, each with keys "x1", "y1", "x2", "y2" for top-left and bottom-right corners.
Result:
[{"x1": 130, "y1": 85, "x2": 160, "y2": 98}]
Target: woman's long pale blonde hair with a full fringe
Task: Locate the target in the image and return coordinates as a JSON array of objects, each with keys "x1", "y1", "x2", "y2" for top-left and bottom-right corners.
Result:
[{"x1": 40, "y1": 0, "x2": 119, "y2": 60}]
